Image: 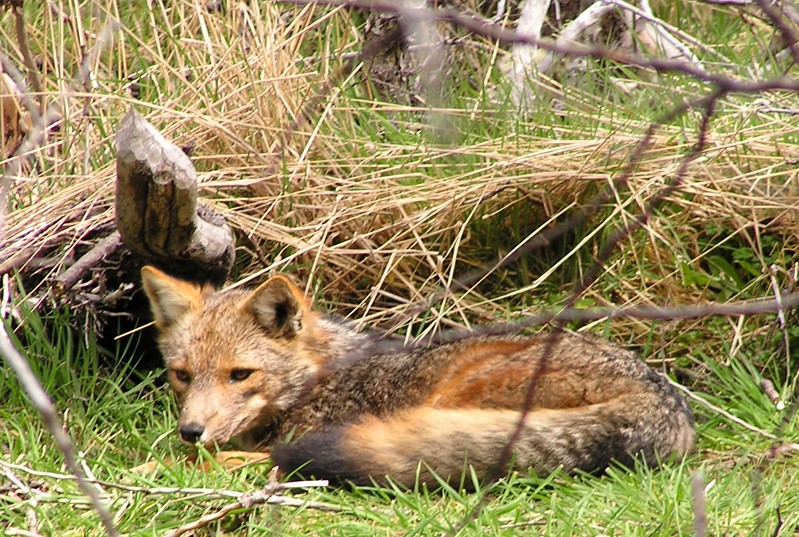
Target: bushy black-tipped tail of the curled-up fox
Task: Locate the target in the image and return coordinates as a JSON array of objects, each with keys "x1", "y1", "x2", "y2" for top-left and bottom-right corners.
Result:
[{"x1": 273, "y1": 394, "x2": 693, "y2": 486}]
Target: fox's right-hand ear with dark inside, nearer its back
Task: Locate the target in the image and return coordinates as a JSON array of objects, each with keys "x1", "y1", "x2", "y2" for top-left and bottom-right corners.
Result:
[{"x1": 244, "y1": 276, "x2": 308, "y2": 338}]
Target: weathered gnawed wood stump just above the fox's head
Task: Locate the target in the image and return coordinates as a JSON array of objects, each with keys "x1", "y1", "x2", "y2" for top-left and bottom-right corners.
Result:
[{"x1": 116, "y1": 108, "x2": 235, "y2": 283}]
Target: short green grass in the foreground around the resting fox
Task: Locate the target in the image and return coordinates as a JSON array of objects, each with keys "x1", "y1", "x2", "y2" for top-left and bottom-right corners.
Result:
[{"x1": 0, "y1": 300, "x2": 799, "y2": 536}]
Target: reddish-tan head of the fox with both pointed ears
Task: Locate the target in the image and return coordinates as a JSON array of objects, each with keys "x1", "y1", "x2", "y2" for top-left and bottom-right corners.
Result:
[{"x1": 142, "y1": 267, "x2": 329, "y2": 447}]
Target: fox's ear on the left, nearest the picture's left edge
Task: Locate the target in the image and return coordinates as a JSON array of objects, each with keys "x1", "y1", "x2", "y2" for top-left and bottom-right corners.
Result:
[{"x1": 141, "y1": 266, "x2": 202, "y2": 330}]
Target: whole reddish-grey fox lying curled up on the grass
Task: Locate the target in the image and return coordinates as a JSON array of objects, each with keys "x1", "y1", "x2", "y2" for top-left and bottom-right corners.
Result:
[{"x1": 141, "y1": 266, "x2": 695, "y2": 487}]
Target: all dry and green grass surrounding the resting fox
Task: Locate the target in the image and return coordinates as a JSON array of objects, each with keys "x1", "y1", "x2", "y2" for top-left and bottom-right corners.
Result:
[{"x1": 0, "y1": 0, "x2": 799, "y2": 536}]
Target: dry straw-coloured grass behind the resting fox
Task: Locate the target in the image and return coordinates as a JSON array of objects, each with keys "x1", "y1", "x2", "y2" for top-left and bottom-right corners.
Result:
[{"x1": 2, "y1": 1, "x2": 799, "y2": 352}]
